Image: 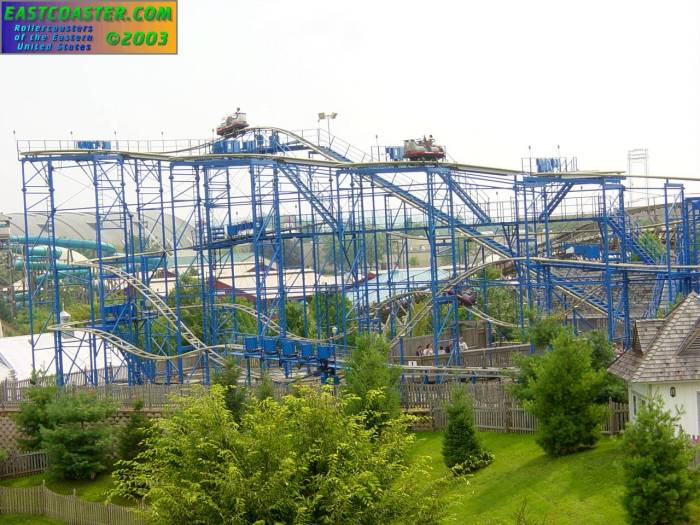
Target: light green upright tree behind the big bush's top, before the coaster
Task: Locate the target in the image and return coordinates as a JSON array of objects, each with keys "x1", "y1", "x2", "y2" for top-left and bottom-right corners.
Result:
[{"x1": 343, "y1": 334, "x2": 401, "y2": 430}]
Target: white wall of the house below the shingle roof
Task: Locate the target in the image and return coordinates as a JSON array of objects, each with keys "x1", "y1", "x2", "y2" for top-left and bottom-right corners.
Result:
[{"x1": 629, "y1": 381, "x2": 700, "y2": 436}]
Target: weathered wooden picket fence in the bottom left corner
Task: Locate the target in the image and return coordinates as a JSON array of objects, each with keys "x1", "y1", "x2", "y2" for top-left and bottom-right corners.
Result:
[{"x1": 0, "y1": 484, "x2": 146, "y2": 525}]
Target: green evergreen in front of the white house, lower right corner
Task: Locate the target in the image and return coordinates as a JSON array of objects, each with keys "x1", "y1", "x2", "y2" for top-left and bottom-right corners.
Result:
[{"x1": 622, "y1": 398, "x2": 700, "y2": 525}]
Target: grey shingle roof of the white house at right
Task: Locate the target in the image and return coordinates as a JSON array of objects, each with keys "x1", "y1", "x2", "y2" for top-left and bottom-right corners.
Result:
[{"x1": 609, "y1": 292, "x2": 700, "y2": 383}]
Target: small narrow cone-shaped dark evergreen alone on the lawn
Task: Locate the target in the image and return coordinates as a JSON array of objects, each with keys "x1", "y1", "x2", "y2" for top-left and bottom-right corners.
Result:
[{"x1": 442, "y1": 388, "x2": 493, "y2": 474}]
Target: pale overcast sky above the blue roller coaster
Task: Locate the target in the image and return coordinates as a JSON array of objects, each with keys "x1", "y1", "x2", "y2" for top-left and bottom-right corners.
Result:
[{"x1": 0, "y1": 0, "x2": 700, "y2": 212}]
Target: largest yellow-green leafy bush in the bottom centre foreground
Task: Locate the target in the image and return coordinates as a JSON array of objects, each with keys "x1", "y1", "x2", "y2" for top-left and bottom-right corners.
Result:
[{"x1": 109, "y1": 385, "x2": 448, "y2": 525}]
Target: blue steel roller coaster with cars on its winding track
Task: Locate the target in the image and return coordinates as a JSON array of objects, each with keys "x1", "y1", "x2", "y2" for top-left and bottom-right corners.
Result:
[{"x1": 13, "y1": 117, "x2": 700, "y2": 384}]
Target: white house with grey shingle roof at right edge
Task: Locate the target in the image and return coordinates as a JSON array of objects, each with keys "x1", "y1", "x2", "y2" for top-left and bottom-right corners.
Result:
[{"x1": 609, "y1": 292, "x2": 700, "y2": 436}]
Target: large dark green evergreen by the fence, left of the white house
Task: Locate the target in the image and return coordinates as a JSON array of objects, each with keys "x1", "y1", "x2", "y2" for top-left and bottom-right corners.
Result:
[{"x1": 516, "y1": 331, "x2": 606, "y2": 456}]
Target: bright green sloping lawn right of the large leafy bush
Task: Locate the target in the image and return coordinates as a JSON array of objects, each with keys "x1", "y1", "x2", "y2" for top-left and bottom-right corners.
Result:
[{"x1": 413, "y1": 432, "x2": 625, "y2": 525}]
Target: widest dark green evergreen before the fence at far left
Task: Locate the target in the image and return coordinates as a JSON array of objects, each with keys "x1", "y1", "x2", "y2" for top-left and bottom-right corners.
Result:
[{"x1": 41, "y1": 392, "x2": 116, "y2": 479}]
